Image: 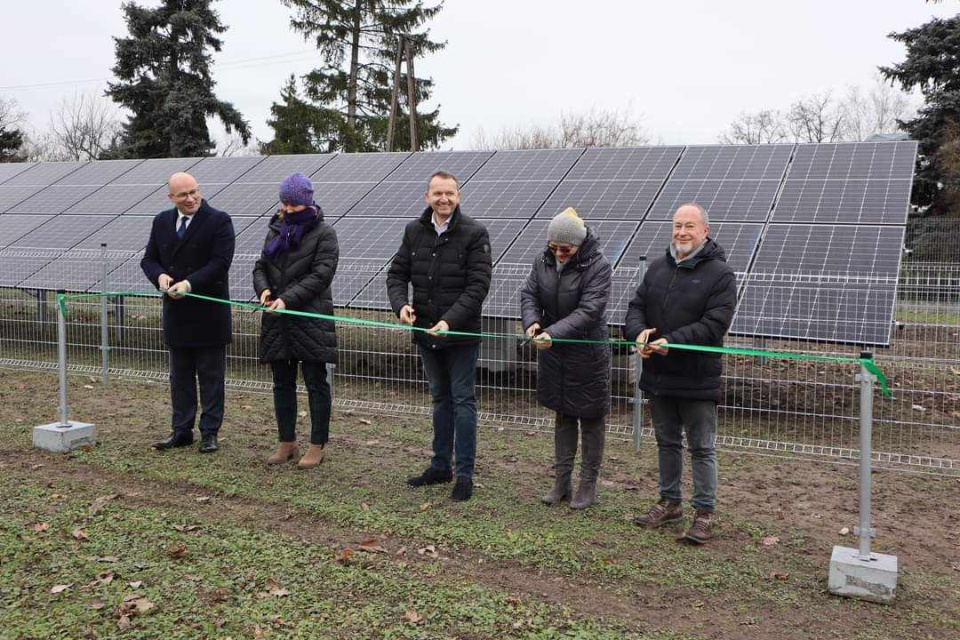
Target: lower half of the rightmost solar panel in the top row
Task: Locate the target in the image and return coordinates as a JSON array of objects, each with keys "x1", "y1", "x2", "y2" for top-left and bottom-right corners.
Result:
[{"x1": 771, "y1": 174, "x2": 912, "y2": 224}]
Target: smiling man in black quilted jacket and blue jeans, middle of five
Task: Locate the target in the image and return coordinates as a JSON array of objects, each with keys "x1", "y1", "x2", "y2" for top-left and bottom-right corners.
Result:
[{"x1": 387, "y1": 171, "x2": 492, "y2": 502}]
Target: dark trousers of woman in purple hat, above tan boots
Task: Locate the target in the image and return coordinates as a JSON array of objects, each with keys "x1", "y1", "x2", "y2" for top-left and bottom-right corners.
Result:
[{"x1": 270, "y1": 360, "x2": 333, "y2": 444}]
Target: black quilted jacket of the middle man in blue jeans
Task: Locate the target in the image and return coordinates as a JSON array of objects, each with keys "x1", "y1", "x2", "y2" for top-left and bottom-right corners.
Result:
[{"x1": 387, "y1": 206, "x2": 493, "y2": 349}]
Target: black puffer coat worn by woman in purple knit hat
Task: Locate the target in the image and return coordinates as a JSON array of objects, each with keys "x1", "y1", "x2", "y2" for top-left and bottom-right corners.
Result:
[{"x1": 253, "y1": 209, "x2": 340, "y2": 362}]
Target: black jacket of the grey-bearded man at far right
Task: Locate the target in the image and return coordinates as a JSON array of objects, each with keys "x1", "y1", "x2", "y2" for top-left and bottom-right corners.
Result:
[{"x1": 624, "y1": 238, "x2": 737, "y2": 402}]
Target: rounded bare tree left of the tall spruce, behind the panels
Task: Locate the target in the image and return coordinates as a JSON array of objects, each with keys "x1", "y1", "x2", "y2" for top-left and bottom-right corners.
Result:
[{"x1": 50, "y1": 94, "x2": 121, "y2": 160}]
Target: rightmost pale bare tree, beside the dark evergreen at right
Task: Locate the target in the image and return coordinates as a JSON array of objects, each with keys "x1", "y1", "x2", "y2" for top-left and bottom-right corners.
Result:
[{"x1": 841, "y1": 75, "x2": 915, "y2": 140}]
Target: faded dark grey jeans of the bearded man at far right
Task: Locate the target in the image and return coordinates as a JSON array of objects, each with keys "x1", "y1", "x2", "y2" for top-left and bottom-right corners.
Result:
[{"x1": 650, "y1": 395, "x2": 717, "y2": 511}]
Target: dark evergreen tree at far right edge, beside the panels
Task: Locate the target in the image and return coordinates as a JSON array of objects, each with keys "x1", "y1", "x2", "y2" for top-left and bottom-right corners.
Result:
[{"x1": 880, "y1": 10, "x2": 960, "y2": 213}]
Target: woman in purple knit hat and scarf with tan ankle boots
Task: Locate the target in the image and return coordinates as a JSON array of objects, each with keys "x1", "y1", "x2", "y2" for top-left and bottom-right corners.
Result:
[{"x1": 253, "y1": 173, "x2": 340, "y2": 469}]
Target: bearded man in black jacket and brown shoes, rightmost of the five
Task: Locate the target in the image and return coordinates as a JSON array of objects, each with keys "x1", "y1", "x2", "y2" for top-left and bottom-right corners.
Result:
[{"x1": 624, "y1": 203, "x2": 737, "y2": 544}]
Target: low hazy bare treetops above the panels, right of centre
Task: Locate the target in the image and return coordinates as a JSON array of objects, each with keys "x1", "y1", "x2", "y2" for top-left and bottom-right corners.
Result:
[{"x1": 472, "y1": 109, "x2": 650, "y2": 149}]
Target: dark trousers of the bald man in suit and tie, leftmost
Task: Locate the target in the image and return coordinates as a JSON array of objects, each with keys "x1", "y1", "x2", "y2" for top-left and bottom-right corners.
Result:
[{"x1": 170, "y1": 345, "x2": 227, "y2": 436}]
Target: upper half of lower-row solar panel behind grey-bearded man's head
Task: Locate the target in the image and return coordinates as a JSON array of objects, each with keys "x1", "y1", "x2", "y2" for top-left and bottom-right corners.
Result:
[{"x1": 620, "y1": 221, "x2": 763, "y2": 273}]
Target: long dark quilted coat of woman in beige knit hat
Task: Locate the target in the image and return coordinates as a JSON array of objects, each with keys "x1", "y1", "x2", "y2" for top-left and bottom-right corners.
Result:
[{"x1": 520, "y1": 228, "x2": 612, "y2": 418}]
